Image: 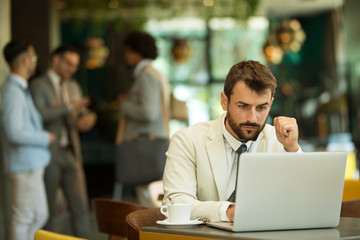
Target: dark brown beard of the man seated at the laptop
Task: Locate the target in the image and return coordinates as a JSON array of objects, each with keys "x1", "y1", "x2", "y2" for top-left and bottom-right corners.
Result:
[{"x1": 226, "y1": 111, "x2": 269, "y2": 142}]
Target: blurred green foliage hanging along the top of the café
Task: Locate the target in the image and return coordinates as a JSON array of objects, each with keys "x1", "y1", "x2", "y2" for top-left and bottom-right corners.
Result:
[{"x1": 58, "y1": 0, "x2": 259, "y2": 32}]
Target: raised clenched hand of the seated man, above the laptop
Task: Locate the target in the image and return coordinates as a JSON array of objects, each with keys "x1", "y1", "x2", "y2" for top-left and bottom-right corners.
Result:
[{"x1": 274, "y1": 117, "x2": 300, "y2": 152}]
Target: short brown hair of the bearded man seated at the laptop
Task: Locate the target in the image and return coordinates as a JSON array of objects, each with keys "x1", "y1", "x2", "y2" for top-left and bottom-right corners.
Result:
[{"x1": 224, "y1": 61, "x2": 277, "y2": 100}]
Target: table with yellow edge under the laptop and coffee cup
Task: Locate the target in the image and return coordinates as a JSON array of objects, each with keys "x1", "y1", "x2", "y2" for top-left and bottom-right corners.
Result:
[{"x1": 140, "y1": 218, "x2": 360, "y2": 240}]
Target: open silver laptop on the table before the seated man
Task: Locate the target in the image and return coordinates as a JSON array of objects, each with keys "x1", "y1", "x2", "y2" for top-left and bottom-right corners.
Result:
[{"x1": 207, "y1": 152, "x2": 347, "y2": 232}]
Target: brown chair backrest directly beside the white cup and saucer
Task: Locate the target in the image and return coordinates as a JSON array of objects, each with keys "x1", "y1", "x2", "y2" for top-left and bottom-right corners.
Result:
[{"x1": 126, "y1": 208, "x2": 166, "y2": 240}]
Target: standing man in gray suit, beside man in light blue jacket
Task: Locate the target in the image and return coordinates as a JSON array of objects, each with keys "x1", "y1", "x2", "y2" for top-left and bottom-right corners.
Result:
[{"x1": 30, "y1": 44, "x2": 96, "y2": 237}]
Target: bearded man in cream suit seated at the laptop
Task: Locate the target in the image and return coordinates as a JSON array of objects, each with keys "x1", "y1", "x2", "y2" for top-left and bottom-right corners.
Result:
[{"x1": 163, "y1": 61, "x2": 301, "y2": 222}]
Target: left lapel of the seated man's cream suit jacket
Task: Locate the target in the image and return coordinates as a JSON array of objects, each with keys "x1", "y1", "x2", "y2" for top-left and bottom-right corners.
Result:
[{"x1": 206, "y1": 116, "x2": 227, "y2": 201}]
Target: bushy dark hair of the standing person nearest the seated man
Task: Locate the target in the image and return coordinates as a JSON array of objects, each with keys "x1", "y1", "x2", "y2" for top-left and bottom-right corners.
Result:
[{"x1": 125, "y1": 31, "x2": 158, "y2": 59}]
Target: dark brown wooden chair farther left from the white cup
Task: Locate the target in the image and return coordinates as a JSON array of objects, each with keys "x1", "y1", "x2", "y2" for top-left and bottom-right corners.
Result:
[{"x1": 92, "y1": 198, "x2": 146, "y2": 240}]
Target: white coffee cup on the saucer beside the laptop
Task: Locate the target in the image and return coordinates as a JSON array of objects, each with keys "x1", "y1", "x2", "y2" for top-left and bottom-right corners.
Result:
[{"x1": 160, "y1": 203, "x2": 192, "y2": 223}]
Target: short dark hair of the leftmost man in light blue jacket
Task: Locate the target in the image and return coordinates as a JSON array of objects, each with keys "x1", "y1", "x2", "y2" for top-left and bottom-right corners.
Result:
[{"x1": 3, "y1": 40, "x2": 32, "y2": 67}]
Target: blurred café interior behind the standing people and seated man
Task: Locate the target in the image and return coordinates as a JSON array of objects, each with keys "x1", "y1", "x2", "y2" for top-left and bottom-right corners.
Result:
[{"x1": 0, "y1": 0, "x2": 360, "y2": 240}]
